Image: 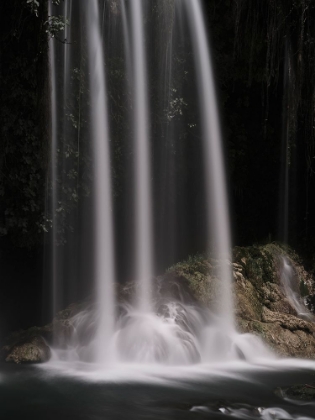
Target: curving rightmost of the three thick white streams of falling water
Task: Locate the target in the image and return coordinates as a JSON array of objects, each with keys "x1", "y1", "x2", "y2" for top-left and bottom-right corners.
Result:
[{"x1": 185, "y1": 0, "x2": 234, "y2": 331}]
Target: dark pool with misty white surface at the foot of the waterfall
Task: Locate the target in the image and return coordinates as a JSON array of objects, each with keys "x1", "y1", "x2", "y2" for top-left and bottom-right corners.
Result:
[{"x1": 0, "y1": 360, "x2": 315, "y2": 420}]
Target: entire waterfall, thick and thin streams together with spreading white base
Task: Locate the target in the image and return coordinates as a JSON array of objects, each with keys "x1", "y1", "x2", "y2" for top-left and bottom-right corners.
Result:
[{"x1": 50, "y1": 0, "x2": 274, "y2": 365}]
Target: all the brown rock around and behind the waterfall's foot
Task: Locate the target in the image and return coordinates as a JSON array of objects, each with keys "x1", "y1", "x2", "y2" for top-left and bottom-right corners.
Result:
[{"x1": 0, "y1": 244, "x2": 315, "y2": 363}]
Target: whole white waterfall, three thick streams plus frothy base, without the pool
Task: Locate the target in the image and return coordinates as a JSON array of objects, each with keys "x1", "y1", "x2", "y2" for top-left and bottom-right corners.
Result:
[{"x1": 47, "y1": 0, "x2": 270, "y2": 365}]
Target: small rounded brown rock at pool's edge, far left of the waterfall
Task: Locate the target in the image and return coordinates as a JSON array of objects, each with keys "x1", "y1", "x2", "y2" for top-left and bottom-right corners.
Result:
[{"x1": 3, "y1": 336, "x2": 51, "y2": 363}]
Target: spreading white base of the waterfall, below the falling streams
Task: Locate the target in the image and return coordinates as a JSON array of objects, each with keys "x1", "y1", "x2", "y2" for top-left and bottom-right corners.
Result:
[{"x1": 49, "y1": 301, "x2": 275, "y2": 366}]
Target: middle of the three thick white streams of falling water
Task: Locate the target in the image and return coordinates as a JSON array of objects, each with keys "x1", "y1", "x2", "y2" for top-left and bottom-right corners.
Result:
[{"x1": 130, "y1": 0, "x2": 153, "y2": 312}]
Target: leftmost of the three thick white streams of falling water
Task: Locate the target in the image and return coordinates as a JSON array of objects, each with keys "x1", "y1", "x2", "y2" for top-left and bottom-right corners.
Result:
[{"x1": 82, "y1": 0, "x2": 115, "y2": 363}]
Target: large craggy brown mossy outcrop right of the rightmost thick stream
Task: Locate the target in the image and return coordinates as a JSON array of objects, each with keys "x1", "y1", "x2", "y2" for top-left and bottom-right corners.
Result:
[{"x1": 234, "y1": 244, "x2": 315, "y2": 358}]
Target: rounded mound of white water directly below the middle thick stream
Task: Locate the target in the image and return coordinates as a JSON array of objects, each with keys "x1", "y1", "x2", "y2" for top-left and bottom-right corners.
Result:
[{"x1": 115, "y1": 302, "x2": 200, "y2": 365}]
